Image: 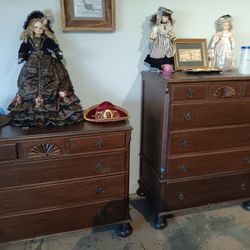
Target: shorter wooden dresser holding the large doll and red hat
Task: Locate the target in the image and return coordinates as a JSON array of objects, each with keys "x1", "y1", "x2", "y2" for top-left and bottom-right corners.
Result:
[{"x1": 0, "y1": 122, "x2": 132, "y2": 242}]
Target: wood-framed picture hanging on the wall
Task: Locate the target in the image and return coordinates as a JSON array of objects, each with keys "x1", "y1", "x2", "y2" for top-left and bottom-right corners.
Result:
[{"x1": 61, "y1": 0, "x2": 115, "y2": 32}]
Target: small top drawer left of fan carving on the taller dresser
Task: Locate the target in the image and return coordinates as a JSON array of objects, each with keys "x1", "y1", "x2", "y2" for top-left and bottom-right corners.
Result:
[{"x1": 172, "y1": 84, "x2": 206, "y2": 101}]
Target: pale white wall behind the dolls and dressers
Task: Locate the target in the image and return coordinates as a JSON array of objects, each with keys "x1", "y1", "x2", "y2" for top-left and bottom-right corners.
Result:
[{"x1": 0, "y1": 0, "x2": 250, "y2": 193}]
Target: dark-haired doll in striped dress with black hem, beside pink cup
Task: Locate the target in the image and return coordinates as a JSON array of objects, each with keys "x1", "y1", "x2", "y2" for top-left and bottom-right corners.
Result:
[{"x1": 144, "y1": 7, "x2": 175, "y2": 69}]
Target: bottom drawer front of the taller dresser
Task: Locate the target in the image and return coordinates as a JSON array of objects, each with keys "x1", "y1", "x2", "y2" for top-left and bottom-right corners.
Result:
[{"x1": 166, "y1": 172, "x2": 250, "y2": 210}]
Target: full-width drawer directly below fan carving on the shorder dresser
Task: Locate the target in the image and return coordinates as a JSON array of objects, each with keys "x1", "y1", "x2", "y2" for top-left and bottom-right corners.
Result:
[{"x1": 0, "y1": 151, "x2": 126, "y2": 188}]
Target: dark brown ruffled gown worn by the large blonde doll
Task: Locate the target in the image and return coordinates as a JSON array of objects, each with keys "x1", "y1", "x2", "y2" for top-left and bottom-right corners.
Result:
[{"x1": 8, "y1": 38, "x2": 83, "y2": 127}]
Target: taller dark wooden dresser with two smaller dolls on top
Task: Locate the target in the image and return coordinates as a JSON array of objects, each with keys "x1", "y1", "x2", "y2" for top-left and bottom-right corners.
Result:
[{"x1": 137, "y1": 72, "x2": 250, "y2": 228}]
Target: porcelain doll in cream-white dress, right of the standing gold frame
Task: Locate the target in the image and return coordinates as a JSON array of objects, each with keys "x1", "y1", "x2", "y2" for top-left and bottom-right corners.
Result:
[{"x1": 209, "y1": 15, "x2": 235, "y2": 70}]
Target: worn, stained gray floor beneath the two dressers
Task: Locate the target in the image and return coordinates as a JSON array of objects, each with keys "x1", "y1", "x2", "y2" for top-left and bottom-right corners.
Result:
[{"x1": 0, "y1": 195, "x2": 250, "y2": 250}]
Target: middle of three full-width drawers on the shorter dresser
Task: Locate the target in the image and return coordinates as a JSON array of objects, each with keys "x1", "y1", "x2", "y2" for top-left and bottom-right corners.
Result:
[{"x1": 0, "y1": 175, "x2": 125, "y2": 217}]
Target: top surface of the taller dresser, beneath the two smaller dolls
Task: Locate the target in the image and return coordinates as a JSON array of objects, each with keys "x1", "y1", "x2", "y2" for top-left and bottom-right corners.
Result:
[{"x1": 142, "y1": 71, "x2": 250, "y2": 84}]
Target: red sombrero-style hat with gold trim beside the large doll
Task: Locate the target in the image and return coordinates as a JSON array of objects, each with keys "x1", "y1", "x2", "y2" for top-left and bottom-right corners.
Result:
[{"x1": 84, "y1": 101, "x2": 129, "y2": 122}]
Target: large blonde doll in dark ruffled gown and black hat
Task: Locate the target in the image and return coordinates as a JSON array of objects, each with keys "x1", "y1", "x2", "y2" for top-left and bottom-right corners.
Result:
[{"x1": 8, "y1": 11, "x2": 83, "y2": 127}]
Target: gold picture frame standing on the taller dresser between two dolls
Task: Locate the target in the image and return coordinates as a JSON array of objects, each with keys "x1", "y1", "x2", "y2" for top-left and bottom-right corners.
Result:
[{"x1": 174, "y1": 38, "x2": 208, "y2": 71}]
